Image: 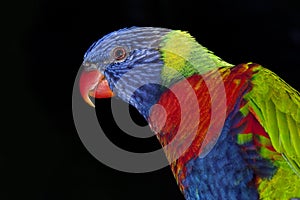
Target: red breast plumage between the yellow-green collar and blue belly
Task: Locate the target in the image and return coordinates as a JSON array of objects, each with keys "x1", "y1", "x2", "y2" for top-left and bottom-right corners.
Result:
[{"x1": 150, "y1": 64, "x2": 263, "y2": 189}]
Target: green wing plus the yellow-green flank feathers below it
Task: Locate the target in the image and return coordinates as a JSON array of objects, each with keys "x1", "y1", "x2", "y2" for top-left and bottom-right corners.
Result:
[{"x1": 245, "y1": 66, "x2": 300, "y2": 199}]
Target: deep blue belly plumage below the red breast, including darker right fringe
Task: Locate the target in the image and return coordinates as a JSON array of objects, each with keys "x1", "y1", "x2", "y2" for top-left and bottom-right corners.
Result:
[{"x1": 183, "y1": 108, "x2": 277, "y2": 200}]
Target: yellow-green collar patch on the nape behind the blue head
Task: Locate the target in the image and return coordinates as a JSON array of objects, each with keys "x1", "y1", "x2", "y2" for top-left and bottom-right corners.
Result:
[{"x1": 160, "y1": 30, "x2": 233, "y2": 87}]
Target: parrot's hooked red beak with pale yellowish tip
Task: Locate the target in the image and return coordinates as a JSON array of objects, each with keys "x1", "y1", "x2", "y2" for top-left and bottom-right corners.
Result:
[{"x1": 79, "y1": 69, "x2": 113, "y2": 107}]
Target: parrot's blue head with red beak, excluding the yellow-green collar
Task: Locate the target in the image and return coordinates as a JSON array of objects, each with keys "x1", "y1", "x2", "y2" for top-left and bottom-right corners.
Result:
[{"x1": 80, "y1": 27, "x2": 171, "y2": 118}]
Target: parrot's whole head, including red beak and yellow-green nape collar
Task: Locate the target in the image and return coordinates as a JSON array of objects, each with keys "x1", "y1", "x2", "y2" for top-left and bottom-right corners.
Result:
[{"x1": 79, "y1": 27, "x2": 230, "y2": 119}]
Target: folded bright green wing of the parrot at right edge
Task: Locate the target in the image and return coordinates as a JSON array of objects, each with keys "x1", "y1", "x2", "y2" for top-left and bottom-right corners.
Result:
[{"x1": 245, "y1": 66, "x2": 300, "y2": 174}]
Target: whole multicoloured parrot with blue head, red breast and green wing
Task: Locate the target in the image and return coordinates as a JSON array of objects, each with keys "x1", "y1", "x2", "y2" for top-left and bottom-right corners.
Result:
[{"x1": 78, "y1": 26, "x2": 300, "y2": 200}]
